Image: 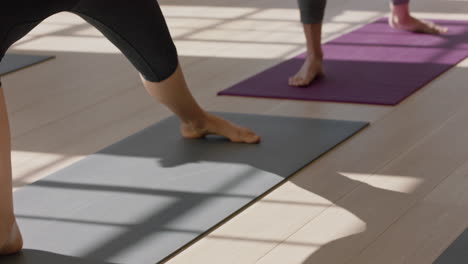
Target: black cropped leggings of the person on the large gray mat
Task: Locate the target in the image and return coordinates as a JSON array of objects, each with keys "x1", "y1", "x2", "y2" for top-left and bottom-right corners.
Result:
[{"x1": 0, "y1": 0, "x2": 178, "y2": 82}]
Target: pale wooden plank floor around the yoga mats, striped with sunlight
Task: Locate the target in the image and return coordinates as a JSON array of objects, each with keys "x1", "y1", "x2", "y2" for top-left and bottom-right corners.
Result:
[{"x1": 2, "y1": 0, "x2": 468, "y2": 264}]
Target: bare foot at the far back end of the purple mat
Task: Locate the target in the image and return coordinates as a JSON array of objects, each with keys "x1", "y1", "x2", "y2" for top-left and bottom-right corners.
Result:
[{"x1": 388, "y1": 4, "x2": 448, "y2": 35}]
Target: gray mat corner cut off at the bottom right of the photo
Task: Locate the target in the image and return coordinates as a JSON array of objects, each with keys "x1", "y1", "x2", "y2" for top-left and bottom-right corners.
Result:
[{"x1": 434, "y1": 229, "x2": 468, "y2": 264}]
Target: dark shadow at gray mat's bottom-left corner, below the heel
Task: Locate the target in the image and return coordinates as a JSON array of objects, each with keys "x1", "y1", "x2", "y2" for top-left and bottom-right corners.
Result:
[{"x1": 0, "y1": 249, "x2": 117, "y2": 264}]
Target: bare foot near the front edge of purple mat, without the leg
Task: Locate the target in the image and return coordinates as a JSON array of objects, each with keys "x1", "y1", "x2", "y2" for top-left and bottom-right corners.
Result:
[{"x1": 289, "y1": 56, "x2": 324, "y2": 87}]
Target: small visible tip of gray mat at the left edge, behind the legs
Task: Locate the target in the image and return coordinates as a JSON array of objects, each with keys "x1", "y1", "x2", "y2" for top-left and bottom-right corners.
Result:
[{"x1": 0, "y1": 54, "x2": 54, "y2": 76}]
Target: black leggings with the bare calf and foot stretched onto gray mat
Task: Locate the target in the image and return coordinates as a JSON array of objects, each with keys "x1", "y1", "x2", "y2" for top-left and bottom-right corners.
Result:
[{"x1": 0, "y1": 0, "x2": 259, "y2": 146}]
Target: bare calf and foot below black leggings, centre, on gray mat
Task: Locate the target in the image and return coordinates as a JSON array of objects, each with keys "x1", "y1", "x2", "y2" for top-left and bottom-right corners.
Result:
[{"x1": 142, "y1": 65, "x2": 260, "y2": 143}]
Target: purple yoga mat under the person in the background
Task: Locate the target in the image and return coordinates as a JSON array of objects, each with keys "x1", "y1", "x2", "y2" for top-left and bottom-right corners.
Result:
[{"x1": 218, "y1": 18, "x2": 468, "y2": 105}]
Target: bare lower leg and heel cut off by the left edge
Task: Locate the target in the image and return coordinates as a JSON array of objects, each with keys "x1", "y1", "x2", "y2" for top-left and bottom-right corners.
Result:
[{"x1": 0, "y1": 87, "x2": 23, "y2": 255}]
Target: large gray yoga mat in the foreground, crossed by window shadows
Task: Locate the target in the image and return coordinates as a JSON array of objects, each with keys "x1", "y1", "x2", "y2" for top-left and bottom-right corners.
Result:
[{"x1": 4, "y1": 113, "x2": 367, "y2": 264}]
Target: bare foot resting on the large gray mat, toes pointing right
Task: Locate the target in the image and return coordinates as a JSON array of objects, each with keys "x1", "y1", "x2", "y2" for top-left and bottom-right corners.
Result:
[{"x1": 181, "y1": 113, "x2": 260, "y2": 144}]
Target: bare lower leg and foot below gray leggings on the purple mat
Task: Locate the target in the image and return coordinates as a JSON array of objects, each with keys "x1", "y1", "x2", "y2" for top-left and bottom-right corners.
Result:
[{"x1": 288, "y1": 23, "x2": 324, "y2": 87}]
